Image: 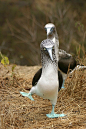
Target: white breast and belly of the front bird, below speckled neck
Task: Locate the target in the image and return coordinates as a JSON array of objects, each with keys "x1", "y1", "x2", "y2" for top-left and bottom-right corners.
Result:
[{"x1": 36, "y1": 66, "x2": 59, "y2": 100}]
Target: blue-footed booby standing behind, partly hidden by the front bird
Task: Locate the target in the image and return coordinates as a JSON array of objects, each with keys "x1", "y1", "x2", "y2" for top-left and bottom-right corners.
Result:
[{"x1": 44, "y1": 23, "x2": 77, "y2": 88}]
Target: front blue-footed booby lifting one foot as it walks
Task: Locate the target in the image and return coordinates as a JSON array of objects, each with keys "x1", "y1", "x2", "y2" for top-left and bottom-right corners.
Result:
[{"x1": 20, "y1": 39, "x2": 65, "y2": 118}]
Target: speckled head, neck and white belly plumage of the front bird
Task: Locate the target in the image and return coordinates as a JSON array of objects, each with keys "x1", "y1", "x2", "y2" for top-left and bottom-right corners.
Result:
[{"x1": 31, "y1": 39, "x2": 59, "y2": 105}]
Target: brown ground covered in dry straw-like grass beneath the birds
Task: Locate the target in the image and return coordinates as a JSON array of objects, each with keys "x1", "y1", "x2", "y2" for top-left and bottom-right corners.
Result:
[{"x1": 0, "y1": 64, "x2": 86, "y2": 129}]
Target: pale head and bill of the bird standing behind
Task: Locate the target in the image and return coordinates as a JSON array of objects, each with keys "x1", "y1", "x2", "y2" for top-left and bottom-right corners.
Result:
[{"x1": 44, "y1": 23, "x2": 55, "y2": 36}]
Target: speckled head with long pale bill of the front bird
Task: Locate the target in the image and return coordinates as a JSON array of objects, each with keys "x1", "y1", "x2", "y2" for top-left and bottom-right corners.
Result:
[{"x1": 40, "y1": 39, "x2": 55, "y2": 61}]
